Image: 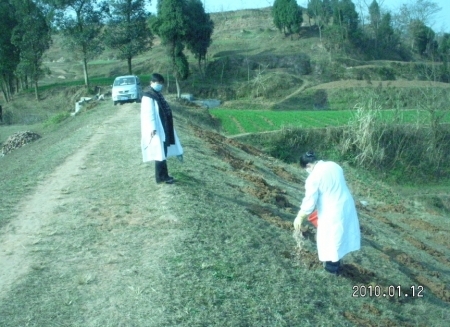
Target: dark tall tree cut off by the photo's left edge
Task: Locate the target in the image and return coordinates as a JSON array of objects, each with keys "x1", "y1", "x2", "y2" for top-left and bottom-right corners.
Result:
[{"x1": 0, "y1": 1, "x2": 20, "y2": 102}]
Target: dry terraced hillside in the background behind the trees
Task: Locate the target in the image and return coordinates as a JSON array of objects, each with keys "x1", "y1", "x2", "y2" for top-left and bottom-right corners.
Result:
[{"x1": 17, "y1": 8, "x2": 442, "y2": 119}]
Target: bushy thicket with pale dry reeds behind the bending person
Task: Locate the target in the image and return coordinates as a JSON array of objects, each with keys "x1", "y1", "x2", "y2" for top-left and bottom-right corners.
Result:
[{"x1": 242, "y1": 98, "x2": 450, "y2": 183}]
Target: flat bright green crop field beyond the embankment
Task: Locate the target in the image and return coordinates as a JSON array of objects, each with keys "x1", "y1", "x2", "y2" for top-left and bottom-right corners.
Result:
[{"x1": 210, "y1": 109, "x2": 450, "y2": 135}]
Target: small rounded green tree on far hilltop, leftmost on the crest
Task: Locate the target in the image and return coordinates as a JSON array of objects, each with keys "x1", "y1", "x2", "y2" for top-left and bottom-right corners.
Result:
[{"x1": 272, "y1": 0, "x2": 303, "y2": 34}]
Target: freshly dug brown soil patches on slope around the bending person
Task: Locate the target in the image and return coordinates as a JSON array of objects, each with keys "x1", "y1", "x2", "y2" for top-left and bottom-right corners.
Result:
[{"x1": 191, "y1": 120, "x2": 450, "y2": 310}]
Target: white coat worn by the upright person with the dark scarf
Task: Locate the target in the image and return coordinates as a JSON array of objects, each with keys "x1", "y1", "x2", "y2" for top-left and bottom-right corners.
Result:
[{"x1": 141, "y1": 96, "x2": 183, "y2": 162}]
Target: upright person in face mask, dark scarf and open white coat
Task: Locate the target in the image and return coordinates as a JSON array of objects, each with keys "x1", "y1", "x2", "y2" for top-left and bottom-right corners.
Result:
[{"x1": 141, "y1": 73, "x2": 183, "y2": 184}]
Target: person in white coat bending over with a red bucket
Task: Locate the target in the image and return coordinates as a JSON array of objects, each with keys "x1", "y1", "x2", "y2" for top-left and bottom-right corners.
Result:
[{"x1": 294, "y1": 151, "x2": 361, "y2": 274}]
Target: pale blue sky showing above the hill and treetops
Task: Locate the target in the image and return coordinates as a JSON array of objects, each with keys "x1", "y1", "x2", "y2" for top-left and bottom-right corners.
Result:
[{"x1": 150, "y1": 0, "x2": 450, "y2": 32}]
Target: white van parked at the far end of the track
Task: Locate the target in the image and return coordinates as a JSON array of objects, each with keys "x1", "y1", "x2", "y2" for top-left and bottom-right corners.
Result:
[{"x1": 111, "y1": 75, "x2": 142, "y2": 105}]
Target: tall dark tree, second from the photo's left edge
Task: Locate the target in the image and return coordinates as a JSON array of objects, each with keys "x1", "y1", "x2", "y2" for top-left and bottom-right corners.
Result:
[{"x1": 12, "y1": 0, "x2": 51, "y2": 100}]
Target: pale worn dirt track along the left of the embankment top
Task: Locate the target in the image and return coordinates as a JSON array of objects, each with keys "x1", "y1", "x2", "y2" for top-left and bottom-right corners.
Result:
[{"x1": 0, "y1": 105, "x2": 146, "y2": 298}]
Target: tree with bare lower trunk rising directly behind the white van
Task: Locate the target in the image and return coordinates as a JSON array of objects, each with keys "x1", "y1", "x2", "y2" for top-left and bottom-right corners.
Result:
[{"x1": 104, "y1": 0, "x2": 153, "y2": 75}]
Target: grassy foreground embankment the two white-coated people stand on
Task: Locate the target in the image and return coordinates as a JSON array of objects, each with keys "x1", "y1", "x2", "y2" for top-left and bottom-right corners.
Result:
[{"x1": 0, "y1": 99, "x2": 450, "y2": 327}]
